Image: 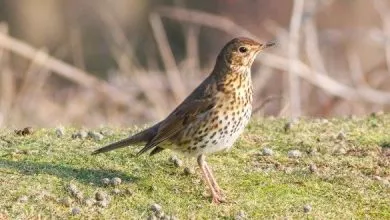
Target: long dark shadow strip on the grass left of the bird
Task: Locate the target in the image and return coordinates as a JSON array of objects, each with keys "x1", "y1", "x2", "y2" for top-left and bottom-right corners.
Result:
[{"x1": 0, "y1": 159, "x2": 137, "y2": 185}]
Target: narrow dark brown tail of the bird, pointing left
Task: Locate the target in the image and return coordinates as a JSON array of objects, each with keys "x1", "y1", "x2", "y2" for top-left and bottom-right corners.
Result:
[{"x1": 92, "y1": 125, "x2": 158, "y2": 154}]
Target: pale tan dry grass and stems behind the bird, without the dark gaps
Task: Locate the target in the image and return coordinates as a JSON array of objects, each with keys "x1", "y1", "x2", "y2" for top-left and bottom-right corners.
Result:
[{"x1": 0, "y1": 0, "x2": 390, "y2": 126}]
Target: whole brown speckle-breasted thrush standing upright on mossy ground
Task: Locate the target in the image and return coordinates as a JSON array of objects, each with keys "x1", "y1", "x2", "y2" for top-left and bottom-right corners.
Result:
[{"x1": 92, "y1": 37, "x2": 275, "y2": 204}]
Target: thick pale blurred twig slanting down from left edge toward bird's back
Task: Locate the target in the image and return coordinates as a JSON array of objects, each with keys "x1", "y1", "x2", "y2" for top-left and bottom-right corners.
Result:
[{"x1": 0, "y1": 33, "x2": 129, "y2": 106}]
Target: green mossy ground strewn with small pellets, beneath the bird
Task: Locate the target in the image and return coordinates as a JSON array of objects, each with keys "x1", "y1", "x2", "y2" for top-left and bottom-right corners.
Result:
[{"x1": 0, "y1": 115, "x2": 390, "y2": 219}]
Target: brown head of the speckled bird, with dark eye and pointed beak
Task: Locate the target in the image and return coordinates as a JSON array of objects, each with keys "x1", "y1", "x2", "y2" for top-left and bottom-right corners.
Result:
[{"x1": 217, "y1": 37, "x2": 275, "y2": 69}]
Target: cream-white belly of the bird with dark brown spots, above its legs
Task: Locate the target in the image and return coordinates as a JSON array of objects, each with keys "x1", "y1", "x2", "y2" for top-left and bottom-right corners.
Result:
[{"x1": 173, "y1": 105, "x2": 252, "y2": 156}]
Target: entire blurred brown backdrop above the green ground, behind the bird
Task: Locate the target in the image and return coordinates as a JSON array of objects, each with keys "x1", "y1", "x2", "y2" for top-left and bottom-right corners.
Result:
[{"x1": 0, "y1": 0, "x2": 390, "y2": 127}]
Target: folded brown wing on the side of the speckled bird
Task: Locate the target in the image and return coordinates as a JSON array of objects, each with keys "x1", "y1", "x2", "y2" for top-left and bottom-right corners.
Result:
[{"x1": 138, "y1": 98, "x2": 215, "y2": 155}]
